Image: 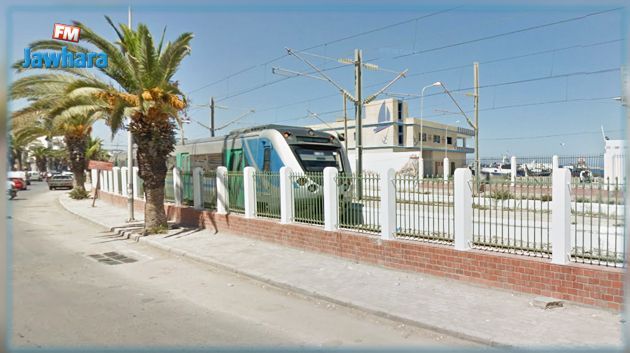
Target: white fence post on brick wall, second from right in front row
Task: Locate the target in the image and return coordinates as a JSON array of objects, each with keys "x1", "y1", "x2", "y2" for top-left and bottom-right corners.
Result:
[{"x1": 453, "y1": 168, "x2": 473, "y2": 251}]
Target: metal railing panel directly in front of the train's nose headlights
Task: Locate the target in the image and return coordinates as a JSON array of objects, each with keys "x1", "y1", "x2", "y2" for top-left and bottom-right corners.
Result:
[{"x1": 289, "y1": 172, "x2": 324, "y2": 225}]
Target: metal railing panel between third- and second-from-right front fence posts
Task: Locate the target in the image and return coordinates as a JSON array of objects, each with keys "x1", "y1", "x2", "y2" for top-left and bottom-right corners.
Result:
[{"x1": 394, "y1": 175, "x2": 455, "y2": 243}]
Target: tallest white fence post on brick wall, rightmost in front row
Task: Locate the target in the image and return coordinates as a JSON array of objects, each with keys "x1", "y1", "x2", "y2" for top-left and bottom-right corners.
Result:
[{"x1": 551, "y1": 168, "x2": 571, "y2": 265}]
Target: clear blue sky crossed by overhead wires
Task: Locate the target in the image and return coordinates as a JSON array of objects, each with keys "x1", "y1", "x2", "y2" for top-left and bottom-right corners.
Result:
[{"x1": 6, "y1": 1, "x2": 627, "y2": 156}]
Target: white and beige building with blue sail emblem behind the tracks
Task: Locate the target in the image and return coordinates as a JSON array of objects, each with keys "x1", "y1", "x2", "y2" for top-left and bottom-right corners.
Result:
[{"x1": 310, "y1": 98, "x2": 475, "y2": 175}]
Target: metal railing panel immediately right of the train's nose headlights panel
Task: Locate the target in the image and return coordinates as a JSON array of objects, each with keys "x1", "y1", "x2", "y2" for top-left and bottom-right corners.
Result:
[{"x1": 335, "y1": 173, "x2": 381, "y2": 232}]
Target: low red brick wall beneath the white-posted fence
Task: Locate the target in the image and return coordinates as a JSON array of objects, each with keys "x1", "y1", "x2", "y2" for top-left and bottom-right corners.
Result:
[{"x1": 97, "y1": 193, "x2": 623, "y2": 310}]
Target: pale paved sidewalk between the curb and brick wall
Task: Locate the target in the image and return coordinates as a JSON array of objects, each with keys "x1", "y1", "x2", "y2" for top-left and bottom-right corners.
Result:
[{"x1": 59, "y1": 194, "x2": 622, "y2": 348}]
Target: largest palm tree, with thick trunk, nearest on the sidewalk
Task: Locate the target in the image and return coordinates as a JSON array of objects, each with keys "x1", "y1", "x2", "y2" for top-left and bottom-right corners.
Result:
[{"x1": 16, "y1": 17, "x2": 193, "y2": 233}]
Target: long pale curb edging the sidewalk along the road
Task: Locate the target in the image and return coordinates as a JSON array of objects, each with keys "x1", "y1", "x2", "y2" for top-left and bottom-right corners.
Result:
[{"x1": 58, "y1": 197, "x2": 504, "y2": 348}]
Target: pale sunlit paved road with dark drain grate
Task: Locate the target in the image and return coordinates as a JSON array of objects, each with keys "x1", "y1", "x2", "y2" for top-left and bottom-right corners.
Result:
[{"x1": 8, "y1": 182, "x2": 473, "y2": 349}]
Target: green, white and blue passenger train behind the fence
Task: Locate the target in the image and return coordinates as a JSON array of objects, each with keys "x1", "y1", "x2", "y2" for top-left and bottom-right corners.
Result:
[{"x1": 168, "y1": 124, "x2": 356, "y2": 213}]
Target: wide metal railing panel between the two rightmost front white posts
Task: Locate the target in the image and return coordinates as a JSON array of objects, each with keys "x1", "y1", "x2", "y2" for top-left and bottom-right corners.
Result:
[{"x1": 471, "y1": 181, "x2": 552, "y2": 257}]
